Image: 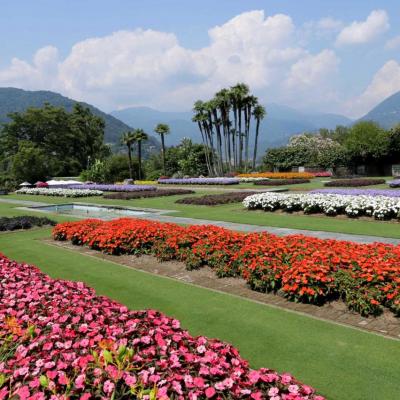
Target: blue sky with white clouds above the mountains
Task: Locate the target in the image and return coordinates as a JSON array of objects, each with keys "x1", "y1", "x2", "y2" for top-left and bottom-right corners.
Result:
[{"x1": 0, "y1": 0, "x2": 400, "y2": 118}]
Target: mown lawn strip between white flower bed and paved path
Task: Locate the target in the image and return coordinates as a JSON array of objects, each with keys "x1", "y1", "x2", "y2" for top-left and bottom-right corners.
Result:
[{"x1": 0, "y1": 190, "x2": 400, "y2": 238}]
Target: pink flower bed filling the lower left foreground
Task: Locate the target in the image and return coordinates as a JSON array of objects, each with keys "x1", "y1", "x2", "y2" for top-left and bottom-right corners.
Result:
[{"x1": 0, "y1": 255, "x2": 323, "y2": 400}]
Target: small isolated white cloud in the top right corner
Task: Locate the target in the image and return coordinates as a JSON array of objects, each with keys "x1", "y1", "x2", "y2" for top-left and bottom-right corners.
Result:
[{"x1": 336, "y1": 10, "x2": 390, "y2": 46}]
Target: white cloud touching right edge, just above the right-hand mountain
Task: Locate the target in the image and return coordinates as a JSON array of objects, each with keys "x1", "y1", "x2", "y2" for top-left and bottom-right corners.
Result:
[{"x1": 344, "y1": 60, "x2": 400, "y2": 117}]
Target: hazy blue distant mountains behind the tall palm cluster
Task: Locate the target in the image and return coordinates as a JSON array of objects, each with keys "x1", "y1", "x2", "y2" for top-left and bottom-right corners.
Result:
[{"x1": 111, "y1": 104, "x2": 352, "y2": 154}]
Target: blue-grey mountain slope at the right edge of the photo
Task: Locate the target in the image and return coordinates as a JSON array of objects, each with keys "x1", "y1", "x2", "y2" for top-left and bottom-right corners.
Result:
[{"x1": 360, "y1": 92, "x2": 400, "y2": 129}]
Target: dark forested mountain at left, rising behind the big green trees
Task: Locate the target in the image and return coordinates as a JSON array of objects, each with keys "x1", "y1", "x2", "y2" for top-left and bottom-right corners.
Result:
[{"x1": 0, "y1": 88, "x2": 160, "y2": 151}]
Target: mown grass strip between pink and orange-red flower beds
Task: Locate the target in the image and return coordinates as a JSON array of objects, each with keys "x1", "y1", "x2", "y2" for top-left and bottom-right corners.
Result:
[{"x1": 0, "y1": 225, "x2": 400, "y2": 400}]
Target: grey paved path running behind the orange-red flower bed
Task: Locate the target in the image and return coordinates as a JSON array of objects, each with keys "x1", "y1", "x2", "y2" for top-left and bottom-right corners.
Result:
[{"x1": 0, "y1": 199, "x2": 400, "y2": 245}]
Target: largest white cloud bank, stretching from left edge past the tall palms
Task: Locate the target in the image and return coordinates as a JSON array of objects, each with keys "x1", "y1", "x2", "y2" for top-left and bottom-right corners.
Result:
[{"x1": 0, "y1": 10, "x2": 338, "y2": 110}]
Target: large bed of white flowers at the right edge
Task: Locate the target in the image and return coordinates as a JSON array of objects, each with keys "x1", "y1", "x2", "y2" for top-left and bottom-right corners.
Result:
[{"x1": 243, "y1": 193, "x2": 400, "y2": 219}]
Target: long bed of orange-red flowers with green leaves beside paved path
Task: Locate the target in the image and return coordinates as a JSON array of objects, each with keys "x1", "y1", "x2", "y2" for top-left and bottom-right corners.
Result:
[{"x1": 53, "y1": 218, "x2": 400, "y2": 315}]
